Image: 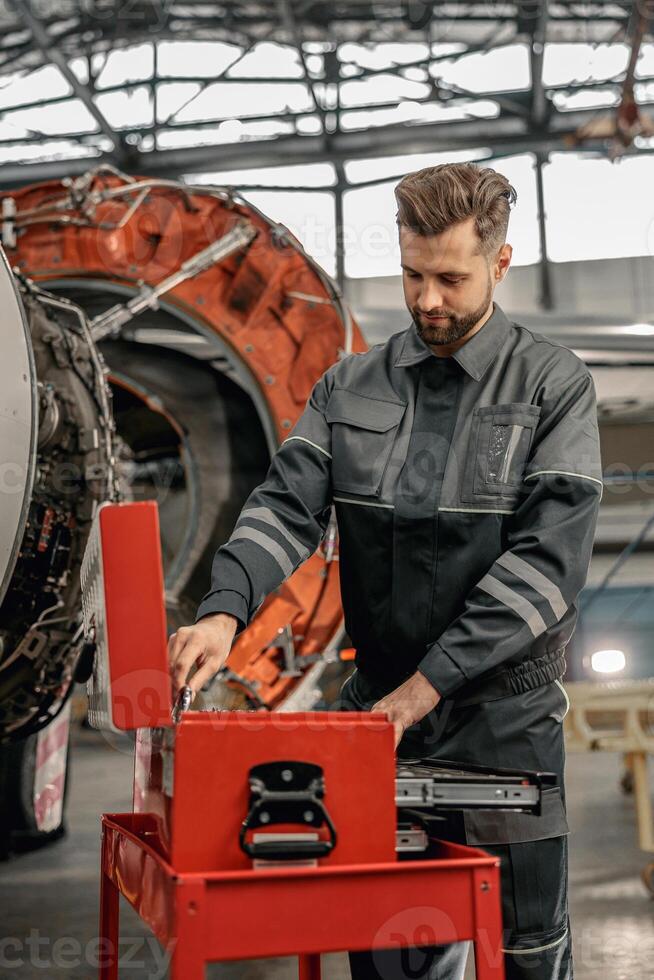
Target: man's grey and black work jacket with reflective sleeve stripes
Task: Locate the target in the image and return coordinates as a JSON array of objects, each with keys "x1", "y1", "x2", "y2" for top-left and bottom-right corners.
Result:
[{"x1": 196, "y1": 305, "x2": 602, "y2": 697}]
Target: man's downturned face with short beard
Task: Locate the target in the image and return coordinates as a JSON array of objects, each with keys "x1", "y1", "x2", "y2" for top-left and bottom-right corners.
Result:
[{"x1": 400, "y1": 218, "x2": 511, "y2": 346}]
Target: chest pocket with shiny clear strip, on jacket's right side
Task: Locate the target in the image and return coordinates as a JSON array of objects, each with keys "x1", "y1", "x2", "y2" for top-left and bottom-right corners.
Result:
[{"x1": 461, "y1": 402, "x2": 540, "y2": 503}]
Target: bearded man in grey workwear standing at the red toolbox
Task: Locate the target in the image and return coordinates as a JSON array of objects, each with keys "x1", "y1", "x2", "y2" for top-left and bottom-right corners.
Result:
[{"x1": 170, "y1": 164, "x2": 602, "y2": 980}]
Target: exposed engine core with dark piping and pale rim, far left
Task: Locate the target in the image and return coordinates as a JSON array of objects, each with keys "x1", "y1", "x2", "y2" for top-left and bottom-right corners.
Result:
[{"x1": 0, "y1": 256, "x2": 118, "y2": 739}]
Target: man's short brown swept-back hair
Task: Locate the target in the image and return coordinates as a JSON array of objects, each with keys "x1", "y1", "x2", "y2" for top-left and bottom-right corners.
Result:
[{"x1": 395, "y1": 163, "x2": 517, "y2": 253}]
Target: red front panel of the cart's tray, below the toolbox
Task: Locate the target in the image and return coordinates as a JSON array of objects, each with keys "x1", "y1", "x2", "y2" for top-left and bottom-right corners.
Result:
[{"x1": 208, "y1": 861, "x2": 482, "y2": 960}]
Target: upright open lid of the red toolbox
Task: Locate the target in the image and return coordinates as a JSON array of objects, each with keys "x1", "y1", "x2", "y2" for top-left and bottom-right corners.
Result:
[{"x1": 81, "y1": 501, "x2": 172, "y2": 731}]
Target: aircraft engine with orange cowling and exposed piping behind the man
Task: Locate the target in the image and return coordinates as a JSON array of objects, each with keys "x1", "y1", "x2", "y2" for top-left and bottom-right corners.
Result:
[{"x1": 0, "y1": 165, "x2": 366, "y2": 732}]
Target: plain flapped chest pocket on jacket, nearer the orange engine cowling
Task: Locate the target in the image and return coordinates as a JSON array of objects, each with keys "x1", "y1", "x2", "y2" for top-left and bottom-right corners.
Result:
[{"x1": 325, "y1": 388, "x2": 406, "y2": 496}]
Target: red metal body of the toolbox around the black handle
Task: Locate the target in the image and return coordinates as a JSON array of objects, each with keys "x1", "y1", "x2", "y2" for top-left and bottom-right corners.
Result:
[{"x1": 134, "y1": 712, "x2": 397, "y2": 873}]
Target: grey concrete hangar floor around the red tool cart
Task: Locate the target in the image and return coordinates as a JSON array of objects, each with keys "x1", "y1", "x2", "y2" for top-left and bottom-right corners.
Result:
[{"x1": 0, "y1": 731, "x2": 654, "y2": 980}]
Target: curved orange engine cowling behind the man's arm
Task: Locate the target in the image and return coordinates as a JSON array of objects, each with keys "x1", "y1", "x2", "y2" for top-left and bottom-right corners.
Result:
[{"x1": 2, "y1": 167, "x2": 366, "y2": 709}]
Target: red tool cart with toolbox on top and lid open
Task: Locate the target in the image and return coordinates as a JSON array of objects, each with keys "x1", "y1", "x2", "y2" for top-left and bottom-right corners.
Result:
[{"x1": 82, "y1": 503, "x2": 504, "y2": 980}]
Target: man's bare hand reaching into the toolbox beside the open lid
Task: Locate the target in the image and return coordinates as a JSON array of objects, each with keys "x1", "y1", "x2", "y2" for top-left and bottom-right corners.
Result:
[{"x1": 168, "y1": 613, "x2": 238, "y2": 700}]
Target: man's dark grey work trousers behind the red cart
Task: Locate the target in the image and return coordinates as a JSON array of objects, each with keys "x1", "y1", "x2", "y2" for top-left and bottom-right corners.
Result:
[{"x1": 332, "y1": 671, "x2": 573, "y2": 980}]
